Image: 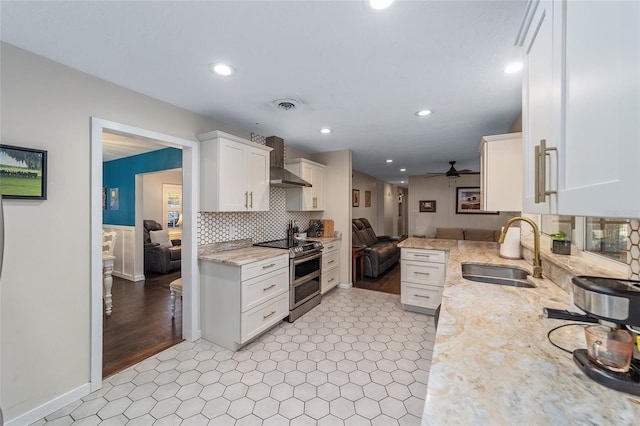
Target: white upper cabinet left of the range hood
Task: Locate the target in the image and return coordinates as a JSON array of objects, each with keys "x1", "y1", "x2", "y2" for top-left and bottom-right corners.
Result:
[{"x1": 198, "y1": 131, "x2": 271, "y2": 212}]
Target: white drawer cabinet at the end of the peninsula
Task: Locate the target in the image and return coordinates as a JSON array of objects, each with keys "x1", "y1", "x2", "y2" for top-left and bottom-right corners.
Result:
[{"x1": 400, "y1": 248, "x2": 447, "y2": 314}]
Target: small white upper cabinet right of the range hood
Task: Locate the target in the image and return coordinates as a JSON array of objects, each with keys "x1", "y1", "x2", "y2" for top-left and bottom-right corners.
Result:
[{"x1": 286, "y1": 158, "x2": 325, "y2": 211}]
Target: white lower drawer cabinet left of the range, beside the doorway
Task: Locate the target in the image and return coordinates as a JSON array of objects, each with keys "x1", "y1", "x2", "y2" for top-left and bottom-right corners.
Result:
[{"x1": 200, "y1": 254, "x2": 289, "y2": 351}]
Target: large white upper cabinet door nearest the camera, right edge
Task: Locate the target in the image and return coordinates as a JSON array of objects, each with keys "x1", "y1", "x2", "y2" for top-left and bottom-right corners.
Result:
[{"x1": 558, "y1": 1, "x2": 640, "y2": 217}]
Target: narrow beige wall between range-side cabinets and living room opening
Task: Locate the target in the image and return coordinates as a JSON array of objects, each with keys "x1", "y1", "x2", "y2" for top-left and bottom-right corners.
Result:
[{"x1": 311, "y1": 150, "x2": 352, "y2": 284}]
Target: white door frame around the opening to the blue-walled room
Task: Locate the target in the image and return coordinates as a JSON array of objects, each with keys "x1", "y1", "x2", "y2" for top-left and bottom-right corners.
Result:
[{"x1": 90, "y1": 117, "x2": 201, "y2": 392}]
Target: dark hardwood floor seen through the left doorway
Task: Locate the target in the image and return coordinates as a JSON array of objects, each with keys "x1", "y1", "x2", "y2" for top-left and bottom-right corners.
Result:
[{"x1": 102, "y1": 271, "x2": 182, "y2": 377}]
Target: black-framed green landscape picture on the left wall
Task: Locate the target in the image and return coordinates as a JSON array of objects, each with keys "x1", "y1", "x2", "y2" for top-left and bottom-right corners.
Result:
[{"x1": 0, "y1": 145, "x2": 47, "y2": 200}]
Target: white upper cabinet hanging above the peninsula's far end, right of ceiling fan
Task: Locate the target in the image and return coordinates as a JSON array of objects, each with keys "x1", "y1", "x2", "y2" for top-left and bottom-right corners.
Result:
[{"x1": 480, "y1": 133, "x2": 522, "y2": 211}]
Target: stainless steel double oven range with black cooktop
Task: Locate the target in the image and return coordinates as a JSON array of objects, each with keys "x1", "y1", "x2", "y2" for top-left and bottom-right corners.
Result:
[{"x1": 254, "y1": 239, "x2": 323, "y2": 322}]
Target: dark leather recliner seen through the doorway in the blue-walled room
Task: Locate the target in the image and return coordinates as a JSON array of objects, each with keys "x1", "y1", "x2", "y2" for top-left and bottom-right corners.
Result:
[{"x1": 143, "y1": 219, "x2": 182, "y2": 275}]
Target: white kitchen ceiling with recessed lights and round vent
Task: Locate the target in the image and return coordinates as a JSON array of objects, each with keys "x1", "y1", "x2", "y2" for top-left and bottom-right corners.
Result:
[{"x1": 1, "y1": 0, "x2": 525, "y2": 183}]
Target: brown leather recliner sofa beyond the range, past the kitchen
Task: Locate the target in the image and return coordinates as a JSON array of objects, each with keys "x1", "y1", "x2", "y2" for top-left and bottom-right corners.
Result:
[{"x1": 351, "y1": 218, "x2": 400, "y2": 278}]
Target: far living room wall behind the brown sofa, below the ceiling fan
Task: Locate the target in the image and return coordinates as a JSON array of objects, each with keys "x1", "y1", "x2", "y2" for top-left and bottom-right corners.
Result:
[{"x1": 407, "y1": 175, "x2": 514, "y2": 237}]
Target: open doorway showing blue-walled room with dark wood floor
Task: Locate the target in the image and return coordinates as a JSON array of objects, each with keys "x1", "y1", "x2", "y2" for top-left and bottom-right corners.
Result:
[{"x1": 102, "y1": 165, "x2": 183, "y2": 378}]
